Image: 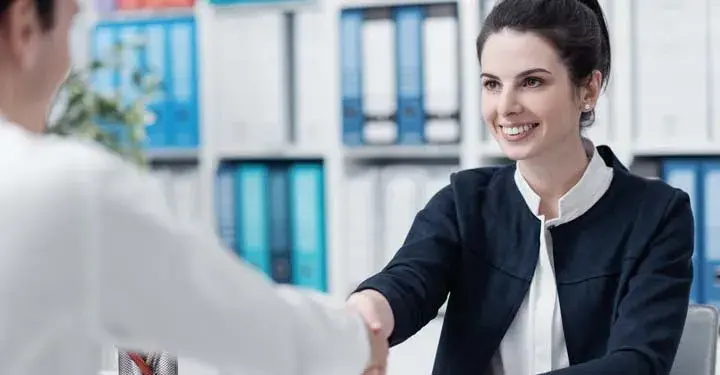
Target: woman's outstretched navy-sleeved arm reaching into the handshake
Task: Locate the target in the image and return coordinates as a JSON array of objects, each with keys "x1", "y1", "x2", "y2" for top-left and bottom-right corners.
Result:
[{"x1": 351, "y1": 186, "x2": 460, "y2": 345}]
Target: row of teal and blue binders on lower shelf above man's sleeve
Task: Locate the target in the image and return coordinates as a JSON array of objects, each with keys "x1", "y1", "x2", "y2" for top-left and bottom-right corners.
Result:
[{"x1": 216, "y1": 161, "x2": 327, "y2": 292}]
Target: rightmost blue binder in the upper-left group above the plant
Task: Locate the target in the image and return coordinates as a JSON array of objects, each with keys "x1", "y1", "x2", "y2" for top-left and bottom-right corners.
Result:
[{"x1": 166, "y1": 18, "x2": 199, "y2": 148}]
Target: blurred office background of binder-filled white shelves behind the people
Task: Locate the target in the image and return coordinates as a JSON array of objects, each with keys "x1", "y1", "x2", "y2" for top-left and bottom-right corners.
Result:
[{"x1": 66, "y1": 0, "x2": 720, "y2": 375}]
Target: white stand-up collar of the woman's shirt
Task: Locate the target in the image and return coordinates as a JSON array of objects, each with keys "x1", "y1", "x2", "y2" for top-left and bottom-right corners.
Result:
[{"x1": 514, "y1": 138, "x2": 613, "y2": 225}]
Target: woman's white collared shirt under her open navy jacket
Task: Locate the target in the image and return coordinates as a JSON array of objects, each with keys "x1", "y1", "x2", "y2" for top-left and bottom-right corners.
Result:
[{"x1": 491, "y1": 140, "x2": 613, "y2": 375}]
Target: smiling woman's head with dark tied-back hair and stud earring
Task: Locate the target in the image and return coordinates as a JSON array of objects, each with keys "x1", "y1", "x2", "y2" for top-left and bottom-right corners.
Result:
[{"x1": 477, "y1": 0, "x2": 611, "y2": 167}]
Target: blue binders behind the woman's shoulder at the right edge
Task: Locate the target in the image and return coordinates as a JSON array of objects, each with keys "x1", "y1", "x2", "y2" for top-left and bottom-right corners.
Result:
[{"x1": 662, "y1": 158, "x2": 720, "y2": 307}]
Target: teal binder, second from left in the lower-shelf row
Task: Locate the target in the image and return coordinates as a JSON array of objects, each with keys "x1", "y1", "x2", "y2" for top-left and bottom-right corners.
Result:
[{"x1": 235, "y1": 163, "x2": 271, "y2": 276}]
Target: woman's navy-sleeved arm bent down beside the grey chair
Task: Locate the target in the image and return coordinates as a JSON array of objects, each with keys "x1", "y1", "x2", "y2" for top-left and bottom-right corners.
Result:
[{"x1": 548, "y1": 191, "x2": 694, "y2": 375}]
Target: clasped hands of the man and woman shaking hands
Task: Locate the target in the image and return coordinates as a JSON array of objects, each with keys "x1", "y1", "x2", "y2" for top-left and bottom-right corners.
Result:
[{"x1": 347, "y1": 289, "x2": 395, "y2": 375}]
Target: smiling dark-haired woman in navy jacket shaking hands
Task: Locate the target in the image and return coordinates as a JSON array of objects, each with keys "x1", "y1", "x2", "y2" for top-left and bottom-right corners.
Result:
[{"x1": 348, "y1": 0, "x2": 694, "y2": 375}]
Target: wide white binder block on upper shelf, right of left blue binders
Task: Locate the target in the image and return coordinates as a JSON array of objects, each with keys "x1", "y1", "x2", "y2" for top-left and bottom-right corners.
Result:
[{"x1": 214, "y1": 12, "x2": 289, "y2": 150}]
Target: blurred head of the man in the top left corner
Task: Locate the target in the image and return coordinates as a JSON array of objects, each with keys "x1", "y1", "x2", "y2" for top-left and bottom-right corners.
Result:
[{"x1": 0, "y1": 0, "x2": 78, "y2": 130}]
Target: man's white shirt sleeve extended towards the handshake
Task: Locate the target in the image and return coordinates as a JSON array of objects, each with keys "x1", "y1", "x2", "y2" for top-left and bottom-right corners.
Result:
[{"x1": 86, "y1": 161, "x2": 370, "y2": 375}]
